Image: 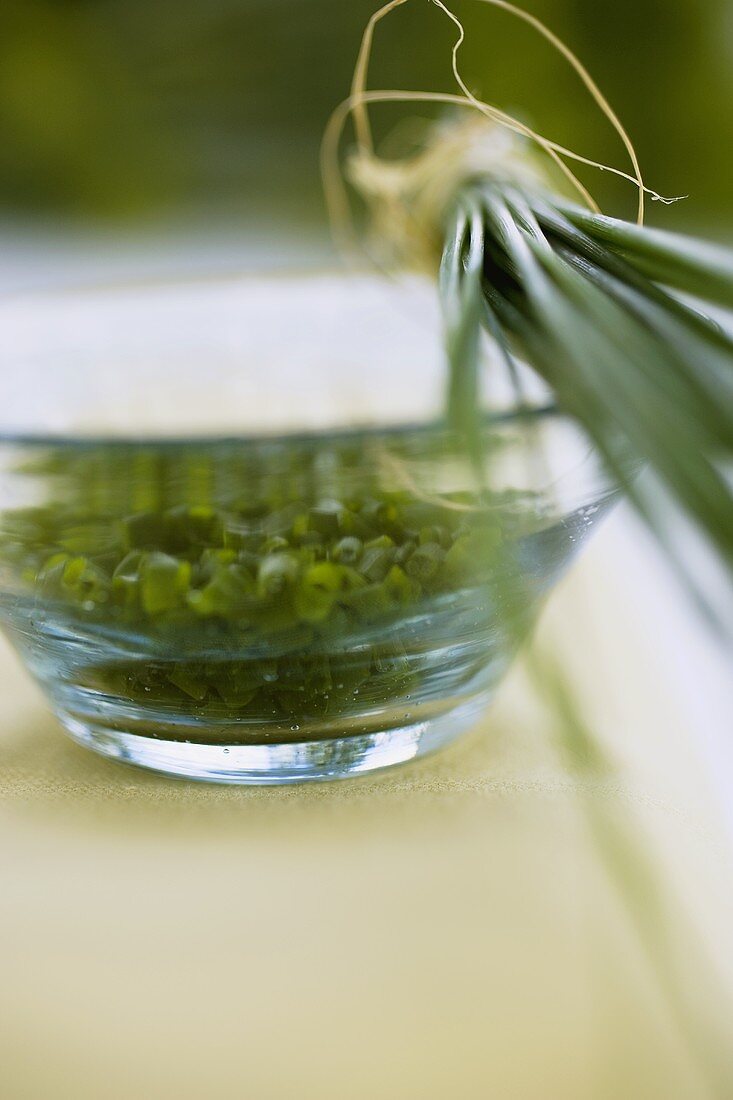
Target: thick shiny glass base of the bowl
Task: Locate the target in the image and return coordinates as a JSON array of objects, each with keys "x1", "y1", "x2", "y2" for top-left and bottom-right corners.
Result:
[{"x1": 57, "y1": 693, "x2": 488, "y2": 785}]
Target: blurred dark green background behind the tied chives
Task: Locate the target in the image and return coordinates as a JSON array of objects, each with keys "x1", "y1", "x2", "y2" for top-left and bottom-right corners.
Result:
[{"x1": 0, "y1": 0, "x2": 733, "y2": 230}]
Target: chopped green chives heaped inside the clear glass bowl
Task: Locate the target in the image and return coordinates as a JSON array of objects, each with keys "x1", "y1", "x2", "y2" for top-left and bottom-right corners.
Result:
[{"x1": 0, "y1": 433, "x2": 512, "y2": 723}]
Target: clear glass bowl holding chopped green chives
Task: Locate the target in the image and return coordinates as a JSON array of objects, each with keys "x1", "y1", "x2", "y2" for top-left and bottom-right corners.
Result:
[{"x1": 0, "y1": 276, "x2": 615, "y2": 783}]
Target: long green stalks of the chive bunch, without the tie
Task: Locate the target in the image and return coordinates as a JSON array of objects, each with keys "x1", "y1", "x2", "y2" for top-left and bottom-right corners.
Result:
[{"x1": 440, "y1": 179, "x2": 733, "y2": 594}]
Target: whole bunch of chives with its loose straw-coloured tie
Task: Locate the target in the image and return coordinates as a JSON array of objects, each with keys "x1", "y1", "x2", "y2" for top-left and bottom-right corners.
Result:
[{"x1": 321, "y1": 0, "x2": 733, "y2": 620}]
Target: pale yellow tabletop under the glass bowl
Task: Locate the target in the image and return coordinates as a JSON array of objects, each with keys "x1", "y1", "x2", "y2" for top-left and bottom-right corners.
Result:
[{"x1": 0, "y1": 518, "x2": 733, "y2": 1100}]
